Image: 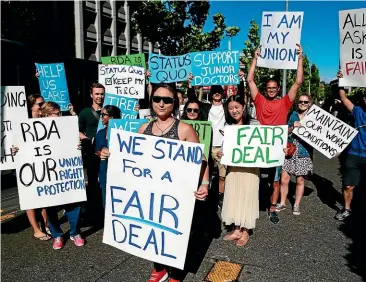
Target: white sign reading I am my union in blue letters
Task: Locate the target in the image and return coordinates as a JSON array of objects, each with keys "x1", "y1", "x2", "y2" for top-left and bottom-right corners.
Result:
[{"x1": 257, "y1": 12, "x2": 304, "y2": 69}]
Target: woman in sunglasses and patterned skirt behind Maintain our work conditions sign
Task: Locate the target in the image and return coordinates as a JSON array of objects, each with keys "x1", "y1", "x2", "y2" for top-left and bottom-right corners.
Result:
[{"x1": 276, "y1": 94, "x2": 313, "y2": 215}]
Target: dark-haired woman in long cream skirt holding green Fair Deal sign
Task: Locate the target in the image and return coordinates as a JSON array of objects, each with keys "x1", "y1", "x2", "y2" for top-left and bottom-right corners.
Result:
[{"x1": 218, "y1": 95, "x2": 259, "y2": 247}]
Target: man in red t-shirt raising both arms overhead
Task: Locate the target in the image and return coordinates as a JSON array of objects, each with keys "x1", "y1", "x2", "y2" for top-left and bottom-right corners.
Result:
[{"x1": 247, "y1": 44, "x2": 304, "y2": 224}]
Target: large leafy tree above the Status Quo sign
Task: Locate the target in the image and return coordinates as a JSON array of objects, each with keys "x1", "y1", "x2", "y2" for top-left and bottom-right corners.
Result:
[{"x1": 129, "y1": 1, "x2": 240, "y2": 55}]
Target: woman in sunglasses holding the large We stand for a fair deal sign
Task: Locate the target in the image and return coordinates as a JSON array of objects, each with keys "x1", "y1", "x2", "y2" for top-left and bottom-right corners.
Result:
[{"x1": 138, "y1": 84, "x2": 209, "y2": 282}]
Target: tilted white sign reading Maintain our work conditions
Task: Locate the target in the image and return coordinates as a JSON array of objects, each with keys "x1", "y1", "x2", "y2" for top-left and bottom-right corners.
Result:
[{"x1": 292, "y1": 105, "x2": 358, "y2": 159}]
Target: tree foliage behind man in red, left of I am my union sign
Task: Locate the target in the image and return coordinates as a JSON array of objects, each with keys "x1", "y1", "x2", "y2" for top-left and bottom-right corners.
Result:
[{"x1": 242, "y1": 20, "x2": 281, "y2": 93}]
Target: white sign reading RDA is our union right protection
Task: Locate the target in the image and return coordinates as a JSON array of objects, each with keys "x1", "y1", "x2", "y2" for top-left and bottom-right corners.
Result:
[{"x1": 16, "y1": 116, "x2": 86, "y2": 210}]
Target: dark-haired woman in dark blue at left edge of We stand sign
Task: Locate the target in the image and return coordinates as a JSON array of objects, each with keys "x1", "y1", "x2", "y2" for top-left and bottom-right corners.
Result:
[{"x1": 95, "y1": 105, "x2": 121, "y2": 210}]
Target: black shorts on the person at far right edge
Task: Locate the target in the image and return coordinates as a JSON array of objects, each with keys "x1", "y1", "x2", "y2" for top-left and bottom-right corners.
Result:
[{"x1": 343, "y1": 154, "x2": 366, "y2": 186}]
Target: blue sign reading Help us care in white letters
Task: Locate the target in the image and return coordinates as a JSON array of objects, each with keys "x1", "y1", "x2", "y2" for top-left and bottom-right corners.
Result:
[{"x1": 36, "y1": 63, "x2": 70, "y2": 111}]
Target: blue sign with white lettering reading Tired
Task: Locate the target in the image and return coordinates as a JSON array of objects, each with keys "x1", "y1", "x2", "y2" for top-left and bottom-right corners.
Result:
[{"x1": 98, "y1": 93, "x2": 139, "y2": 131}]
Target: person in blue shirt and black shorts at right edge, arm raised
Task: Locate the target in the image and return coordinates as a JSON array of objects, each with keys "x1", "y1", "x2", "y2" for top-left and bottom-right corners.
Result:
[{"x1": 335, "y1": 72, "x2": 366, "y2": 220}]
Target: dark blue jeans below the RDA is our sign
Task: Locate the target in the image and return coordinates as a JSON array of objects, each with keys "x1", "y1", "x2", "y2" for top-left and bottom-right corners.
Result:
[{"x1": 46, "y1": 203, "x2": 81, "y2": 238}]
